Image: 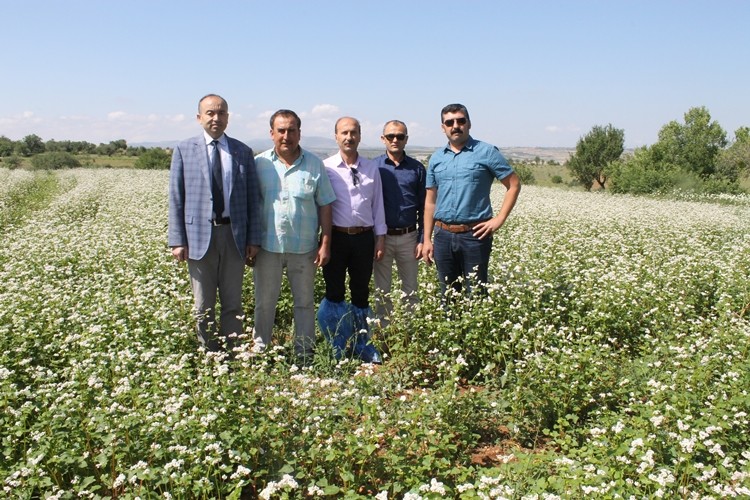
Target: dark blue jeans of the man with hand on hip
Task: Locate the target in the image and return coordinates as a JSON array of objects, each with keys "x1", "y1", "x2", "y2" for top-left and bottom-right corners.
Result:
[{"x1": 432, "y1": 227, "x2": 492, "y2": 295}]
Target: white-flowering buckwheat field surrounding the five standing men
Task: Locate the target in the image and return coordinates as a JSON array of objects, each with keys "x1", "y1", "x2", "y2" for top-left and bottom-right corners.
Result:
[{"x1": 0, "y1": 169, "x2": 750, "y2": 499}]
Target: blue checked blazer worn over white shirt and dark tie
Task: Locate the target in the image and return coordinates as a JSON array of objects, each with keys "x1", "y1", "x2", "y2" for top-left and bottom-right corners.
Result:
[{"x1": 168, "y1": 134, "x2": 261, "y2": 260}]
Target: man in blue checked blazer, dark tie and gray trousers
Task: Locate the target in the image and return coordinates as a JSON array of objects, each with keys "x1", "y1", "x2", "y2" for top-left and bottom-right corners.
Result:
[{"x1": 168, "y1": 94, "x2": 261, "y2": 353}]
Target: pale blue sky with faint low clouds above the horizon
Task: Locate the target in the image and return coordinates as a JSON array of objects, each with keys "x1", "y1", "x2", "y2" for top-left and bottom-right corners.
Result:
[{"x1": 0, "y1": 0, "x2": 750, "y2": 147}]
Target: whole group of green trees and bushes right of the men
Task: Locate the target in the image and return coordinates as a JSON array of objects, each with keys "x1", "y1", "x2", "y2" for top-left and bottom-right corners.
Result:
[{"x1": 566, "y1": 107, "x2": 750, "y2": 194}]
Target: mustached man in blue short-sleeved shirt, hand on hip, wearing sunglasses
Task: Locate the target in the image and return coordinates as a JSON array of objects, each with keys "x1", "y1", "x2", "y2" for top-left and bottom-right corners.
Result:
[{"x1": 422, "y1": 104, "x2": 521, "y2": 294}]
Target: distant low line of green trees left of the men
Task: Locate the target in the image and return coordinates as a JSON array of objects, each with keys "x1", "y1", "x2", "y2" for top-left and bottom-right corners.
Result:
[{"x1": 0, "y1": 134, "x2": 171, "y2": 170}]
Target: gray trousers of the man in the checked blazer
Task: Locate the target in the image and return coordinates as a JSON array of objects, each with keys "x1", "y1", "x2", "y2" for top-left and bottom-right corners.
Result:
[{"x1": 188, "y1": 224, "x2": 245, "y2": 352}]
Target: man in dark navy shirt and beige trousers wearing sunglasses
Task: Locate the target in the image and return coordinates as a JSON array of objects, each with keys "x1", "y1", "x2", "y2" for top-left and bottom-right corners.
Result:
[{"x1": 374, "y1": 120, "x2": 426, "y2": 325}]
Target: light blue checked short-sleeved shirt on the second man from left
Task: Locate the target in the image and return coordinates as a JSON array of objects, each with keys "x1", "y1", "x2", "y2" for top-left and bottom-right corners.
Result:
[{"x1": 255, "y1": 148, "x2": 336, "y2": 254}]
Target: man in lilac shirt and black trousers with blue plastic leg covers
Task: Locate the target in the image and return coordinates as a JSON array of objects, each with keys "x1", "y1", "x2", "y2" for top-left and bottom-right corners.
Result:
[{"x1": 318, "y1": 117, "x2": 387, "y2": 363}]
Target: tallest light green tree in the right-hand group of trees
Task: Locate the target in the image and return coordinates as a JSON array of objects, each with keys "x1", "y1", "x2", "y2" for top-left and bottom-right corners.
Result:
[{"x1": 653, "y1": 107, "x2": 727, "y2": 180}]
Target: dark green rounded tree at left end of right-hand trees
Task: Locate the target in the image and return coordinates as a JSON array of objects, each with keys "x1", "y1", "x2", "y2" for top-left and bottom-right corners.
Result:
[{"x1": 567, "y1": 124, "x2": 625, "y2": 191}]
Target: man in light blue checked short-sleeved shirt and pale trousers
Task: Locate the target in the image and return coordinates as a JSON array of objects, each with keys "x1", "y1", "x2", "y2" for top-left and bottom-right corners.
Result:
[{"x1": 253, "y1": 109, "x2": 336, "y2": 361}]
